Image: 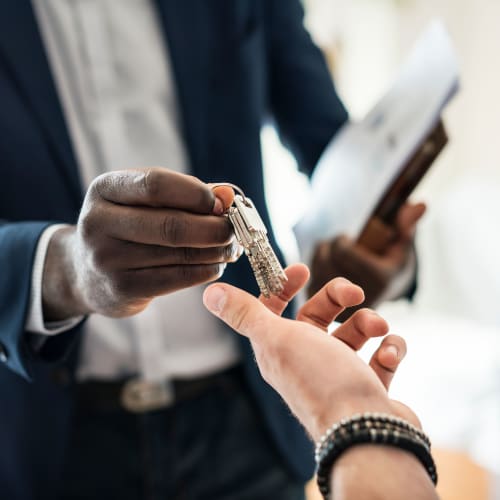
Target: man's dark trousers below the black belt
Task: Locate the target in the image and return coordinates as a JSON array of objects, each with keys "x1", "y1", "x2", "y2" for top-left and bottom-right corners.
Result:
[{"x1": 60, "y1": 371, "x2": 304, "y2": 500}]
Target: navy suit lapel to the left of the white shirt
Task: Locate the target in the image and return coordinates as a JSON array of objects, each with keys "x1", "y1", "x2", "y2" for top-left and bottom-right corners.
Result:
[{"x1": 0, "y1": 0, "x2": 82, "y2": 203}]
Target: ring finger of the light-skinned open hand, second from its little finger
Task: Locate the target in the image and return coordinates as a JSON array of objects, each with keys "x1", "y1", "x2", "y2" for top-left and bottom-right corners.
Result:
[{"x1": 332, "y1": 309, "x2": 389, "y2": 351}]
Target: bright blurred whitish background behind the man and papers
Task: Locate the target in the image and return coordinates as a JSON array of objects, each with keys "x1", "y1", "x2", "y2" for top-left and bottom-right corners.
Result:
[{"x1": 263, "y1": 0, "x2": 500, "y2": 500}]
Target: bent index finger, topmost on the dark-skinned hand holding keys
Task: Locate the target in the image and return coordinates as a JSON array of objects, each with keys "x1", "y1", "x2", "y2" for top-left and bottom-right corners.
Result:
[{"x1": 90, "y1": 167, "x2": 215, "y2": 214}]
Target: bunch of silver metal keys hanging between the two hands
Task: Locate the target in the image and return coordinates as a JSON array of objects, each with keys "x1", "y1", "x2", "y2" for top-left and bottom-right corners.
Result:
[{"x1": 213, "y1": 183, "x2": 288, "y2": 298}]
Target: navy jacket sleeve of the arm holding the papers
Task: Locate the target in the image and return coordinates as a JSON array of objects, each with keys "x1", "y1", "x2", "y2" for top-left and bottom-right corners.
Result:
[{"x1": 265, "y1": 0, "x2": 348, "y2": 174}]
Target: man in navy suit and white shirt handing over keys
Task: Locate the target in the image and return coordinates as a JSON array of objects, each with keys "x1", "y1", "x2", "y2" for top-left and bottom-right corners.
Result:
[{"x1": 0, "y1": 0, "x2": 422, "y2": 500}]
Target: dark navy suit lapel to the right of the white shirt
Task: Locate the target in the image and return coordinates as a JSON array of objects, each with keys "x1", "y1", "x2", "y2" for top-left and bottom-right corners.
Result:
[{"x1": 156, "y1": 0, "x2": 212, "y2": 180}]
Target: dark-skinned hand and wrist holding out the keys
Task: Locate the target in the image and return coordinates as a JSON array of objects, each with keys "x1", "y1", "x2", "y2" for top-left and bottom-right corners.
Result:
[{"x1": 42, "y1": 168, "x2": 240, "y2": 321}]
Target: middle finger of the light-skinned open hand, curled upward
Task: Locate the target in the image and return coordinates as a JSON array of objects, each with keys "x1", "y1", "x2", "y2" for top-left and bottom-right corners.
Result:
[{"x1": 297, "y1": 278, "x2": 365, "y2": 331}]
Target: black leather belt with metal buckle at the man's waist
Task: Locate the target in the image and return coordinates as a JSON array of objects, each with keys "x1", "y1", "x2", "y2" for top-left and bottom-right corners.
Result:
[{"x1": 77, "y1": 366, "x2": 243, "y2": 413}]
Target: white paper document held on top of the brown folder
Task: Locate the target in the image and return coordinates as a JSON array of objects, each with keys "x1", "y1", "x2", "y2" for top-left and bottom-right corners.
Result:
[{"x1": 294, "y1": 21, "x2": 459, "y2": 259}]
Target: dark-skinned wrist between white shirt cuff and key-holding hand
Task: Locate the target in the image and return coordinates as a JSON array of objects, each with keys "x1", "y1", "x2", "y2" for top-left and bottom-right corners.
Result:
[{"x1": 42, "y1": 226, "x2": 91, "y2": 322}]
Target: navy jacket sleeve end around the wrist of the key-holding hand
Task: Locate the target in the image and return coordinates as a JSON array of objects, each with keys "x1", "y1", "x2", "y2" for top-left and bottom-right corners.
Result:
[{"x1": 0, "y1": 221, "x2": 78, "y2": 379}]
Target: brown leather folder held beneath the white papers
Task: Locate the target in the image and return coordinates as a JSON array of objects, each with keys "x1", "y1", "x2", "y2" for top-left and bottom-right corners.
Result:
[{"x1": 358, "y1": 120, "x2": 448, "y2": 253}]
